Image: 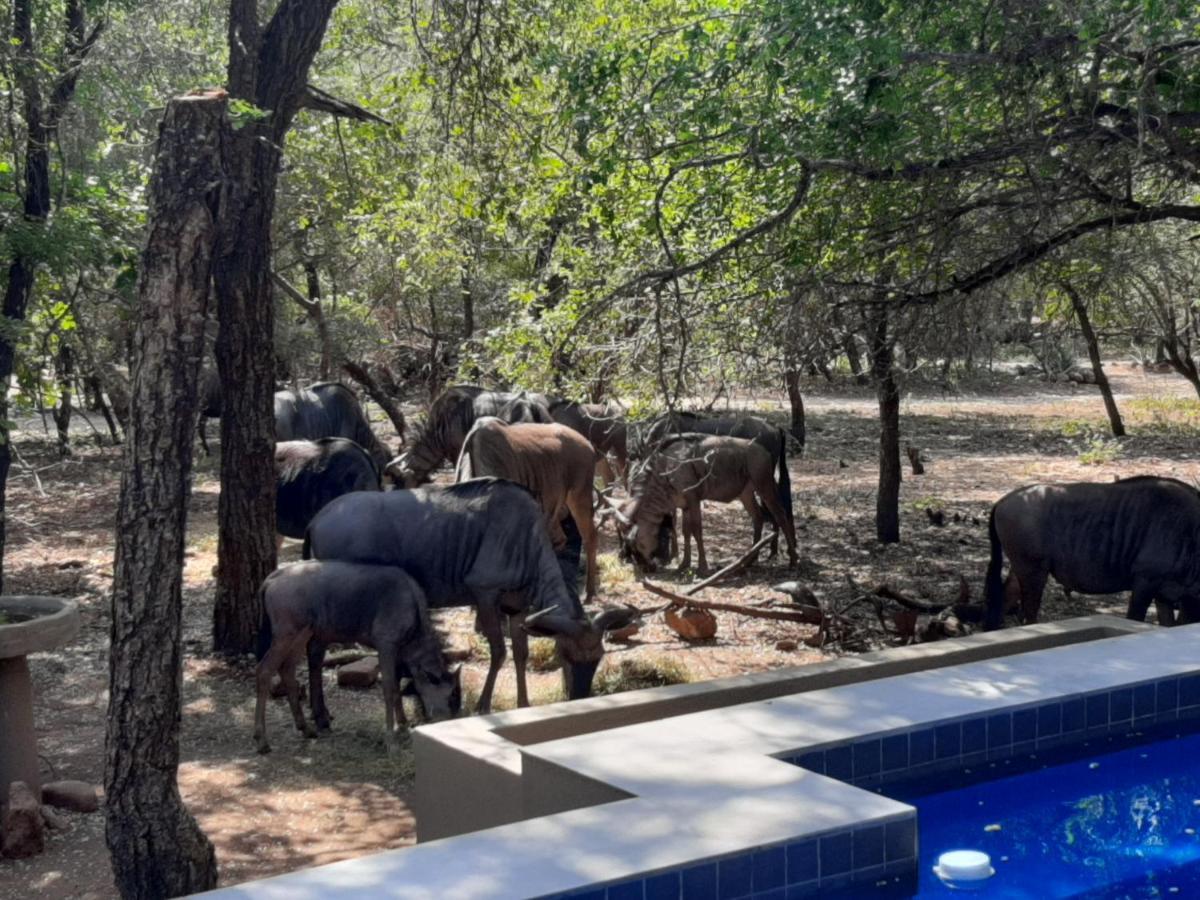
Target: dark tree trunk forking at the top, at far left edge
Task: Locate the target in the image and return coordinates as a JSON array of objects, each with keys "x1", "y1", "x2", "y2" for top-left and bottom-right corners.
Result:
[{"x1": 0, "y1": 0, "x2": 104, "y2": 589}]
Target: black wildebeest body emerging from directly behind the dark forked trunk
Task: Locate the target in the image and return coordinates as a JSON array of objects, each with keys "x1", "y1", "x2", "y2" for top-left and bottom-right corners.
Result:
[{"x1": 275, "y1": 438, "x2": 379, "y2": 539}]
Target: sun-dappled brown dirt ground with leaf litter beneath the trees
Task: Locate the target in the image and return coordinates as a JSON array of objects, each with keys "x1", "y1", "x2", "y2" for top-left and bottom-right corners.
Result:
[{"x1": 0, "y1": 366, "x2": 1200, "y2": 900}]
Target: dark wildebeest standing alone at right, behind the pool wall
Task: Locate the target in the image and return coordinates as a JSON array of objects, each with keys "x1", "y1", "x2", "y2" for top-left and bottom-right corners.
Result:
[{"x1": 984, "y1": 475, "x2": 1200, "y2": 630}]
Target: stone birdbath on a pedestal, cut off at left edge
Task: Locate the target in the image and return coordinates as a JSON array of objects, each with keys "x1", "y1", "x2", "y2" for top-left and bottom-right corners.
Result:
[{"x1": 0, "y1": 596, "x2": 79, "y2": 804}]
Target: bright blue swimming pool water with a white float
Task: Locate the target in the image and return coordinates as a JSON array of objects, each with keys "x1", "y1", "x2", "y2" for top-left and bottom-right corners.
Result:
[{"x1": 886, "y1": 734, "x2": 1200, "y2": 900}]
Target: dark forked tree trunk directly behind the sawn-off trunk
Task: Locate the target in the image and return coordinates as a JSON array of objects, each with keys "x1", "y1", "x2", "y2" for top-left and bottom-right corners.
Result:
[{"x1": 212, "y1": 0, "x2": 337, "y2": 653}]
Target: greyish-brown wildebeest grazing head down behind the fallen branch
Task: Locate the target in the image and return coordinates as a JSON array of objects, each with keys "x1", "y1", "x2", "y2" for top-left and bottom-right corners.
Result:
[{"x1": 616, "y1": 434, "x2": 797, "y2": 572}]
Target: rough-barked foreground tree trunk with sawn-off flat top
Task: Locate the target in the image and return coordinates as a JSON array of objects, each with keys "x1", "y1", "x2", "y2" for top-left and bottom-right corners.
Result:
[{"x1": 104, "y1": 92, "x2": 226, "y2": 900}]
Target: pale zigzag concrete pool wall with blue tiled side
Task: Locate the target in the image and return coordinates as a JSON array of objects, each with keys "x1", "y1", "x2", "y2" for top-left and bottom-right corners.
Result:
[{"x1": 199, "y1": 617, "x2": 1200, "y2": 900}]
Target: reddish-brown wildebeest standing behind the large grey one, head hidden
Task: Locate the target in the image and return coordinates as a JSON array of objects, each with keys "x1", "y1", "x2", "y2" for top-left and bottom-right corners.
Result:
[{"x1": 455, "y1": 415, "x2": 596, "y2": 600}]
